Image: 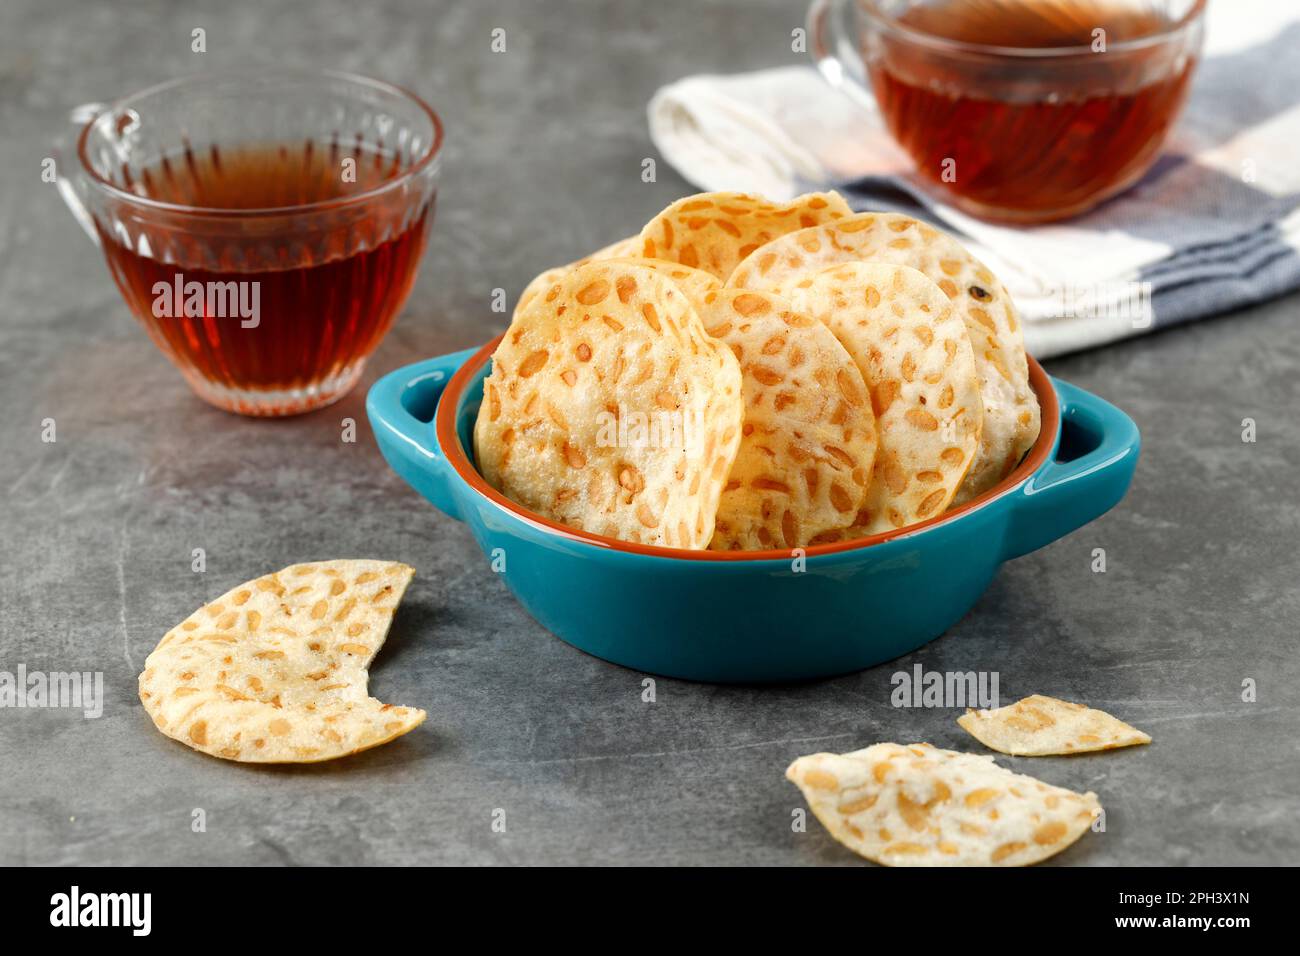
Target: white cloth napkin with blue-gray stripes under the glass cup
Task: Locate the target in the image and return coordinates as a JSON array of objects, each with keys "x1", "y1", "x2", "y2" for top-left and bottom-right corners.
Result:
[{"x1": 647, "y1": 0, "x2": 1300, "y2": 358}]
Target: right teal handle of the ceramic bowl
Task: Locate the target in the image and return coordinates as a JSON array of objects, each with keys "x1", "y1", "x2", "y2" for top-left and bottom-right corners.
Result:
[{"x1": 1002, "y1": 378, "x2": 1140, "y2": 561}]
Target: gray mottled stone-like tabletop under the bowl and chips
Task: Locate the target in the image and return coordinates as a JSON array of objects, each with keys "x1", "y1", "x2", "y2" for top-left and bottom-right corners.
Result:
[{"x1": 0, "y1": 0, "x2": 1300, "y2": 865}]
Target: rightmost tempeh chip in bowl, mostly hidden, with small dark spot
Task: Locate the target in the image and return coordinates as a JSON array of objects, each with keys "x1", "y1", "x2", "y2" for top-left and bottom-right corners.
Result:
[{"x1": 727, "y1": 212, "x2": 1040, "y2": 505}]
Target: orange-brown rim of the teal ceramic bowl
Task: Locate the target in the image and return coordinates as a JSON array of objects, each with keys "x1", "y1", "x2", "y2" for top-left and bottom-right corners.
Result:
[{"x1": 432, "y1": 333, "x2": 1061, "y2": 562}]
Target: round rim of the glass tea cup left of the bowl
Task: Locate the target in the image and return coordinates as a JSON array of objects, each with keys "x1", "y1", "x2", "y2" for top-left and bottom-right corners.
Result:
[{"x1": 77, "y1": 66, "x2": 443, "y2": 219}]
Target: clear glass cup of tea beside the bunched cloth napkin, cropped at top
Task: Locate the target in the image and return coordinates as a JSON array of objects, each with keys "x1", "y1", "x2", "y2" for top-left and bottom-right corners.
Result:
[{"x1": 809, "y1": 0, "x2": 1206, "y2": 222}]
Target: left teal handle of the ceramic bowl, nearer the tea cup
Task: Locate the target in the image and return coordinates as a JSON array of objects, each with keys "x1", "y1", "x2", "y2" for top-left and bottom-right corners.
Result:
[{"x1": 365, "y1": 349, "x2": 478, "y2": 520}]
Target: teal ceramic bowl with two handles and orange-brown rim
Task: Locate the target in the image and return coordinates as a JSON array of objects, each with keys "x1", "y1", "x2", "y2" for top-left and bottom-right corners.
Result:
[{"x1": 367, "y1": 339, "x2": 1139, "y2": 682}]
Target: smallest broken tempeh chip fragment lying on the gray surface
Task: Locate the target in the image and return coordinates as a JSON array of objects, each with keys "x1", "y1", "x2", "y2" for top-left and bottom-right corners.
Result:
[{"x1": 957, "y1": 693, "x2": 1151, "y2": 757}]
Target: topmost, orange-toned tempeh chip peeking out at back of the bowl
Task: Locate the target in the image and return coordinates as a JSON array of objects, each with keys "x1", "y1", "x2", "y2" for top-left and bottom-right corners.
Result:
[{"x1": 641, "y1": 193, "x2": 853, "y2": 281}]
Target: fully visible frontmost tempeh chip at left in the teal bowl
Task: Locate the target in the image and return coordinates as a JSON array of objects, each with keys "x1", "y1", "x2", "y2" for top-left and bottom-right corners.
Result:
[{"x1": 475, "y1": 261, "x2": 745, "y2": 550}]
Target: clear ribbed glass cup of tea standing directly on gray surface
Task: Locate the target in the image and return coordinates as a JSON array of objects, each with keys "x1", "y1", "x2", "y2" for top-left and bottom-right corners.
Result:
[{"x1": 56, "y1": 69, "x2": 442, "y2": 415}]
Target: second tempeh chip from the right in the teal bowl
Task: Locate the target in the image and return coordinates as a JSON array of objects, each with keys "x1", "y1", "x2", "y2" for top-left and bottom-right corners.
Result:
[{"x1": 787, "y1": 263, "x2": 984, "y2": 537}]
